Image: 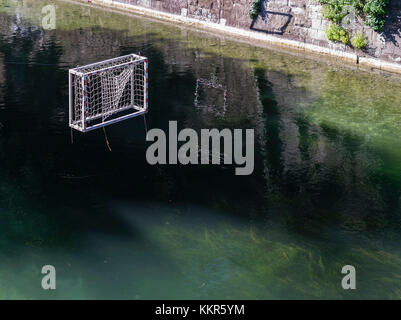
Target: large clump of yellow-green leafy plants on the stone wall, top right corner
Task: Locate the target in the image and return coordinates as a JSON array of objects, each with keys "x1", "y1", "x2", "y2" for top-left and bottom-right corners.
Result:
[{"x1": 319, "y1": 0, "x2": 389, "y2": 49}]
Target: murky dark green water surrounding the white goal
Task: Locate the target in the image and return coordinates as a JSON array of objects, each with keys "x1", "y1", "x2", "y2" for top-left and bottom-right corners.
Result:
[{"x1": 0, "y1": 0, "x2": 401, "y2": 299}]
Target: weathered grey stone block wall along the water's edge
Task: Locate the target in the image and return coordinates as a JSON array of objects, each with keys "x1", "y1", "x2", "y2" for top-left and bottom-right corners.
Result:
[{"x1": 108, "y1": 0, "x2": 401, "y2": 64}]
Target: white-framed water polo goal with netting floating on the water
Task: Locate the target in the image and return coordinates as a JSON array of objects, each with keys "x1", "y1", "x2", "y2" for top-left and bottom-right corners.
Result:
[{"x1": 69, "y1": 54, "x2": 148, "y2": 132}]
